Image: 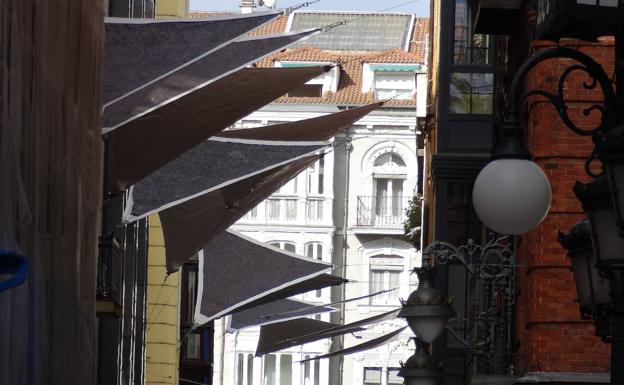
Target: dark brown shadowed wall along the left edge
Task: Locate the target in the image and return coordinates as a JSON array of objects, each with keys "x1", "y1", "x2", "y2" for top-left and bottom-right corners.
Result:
[{"x1": 0, "y1": 0, "x2": 103, "y2": 385}]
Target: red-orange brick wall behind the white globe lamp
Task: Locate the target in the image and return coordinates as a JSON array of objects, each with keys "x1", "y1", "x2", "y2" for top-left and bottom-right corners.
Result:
[{"x1": 517, "y1": 39, "x2": 613, "y2": 374}]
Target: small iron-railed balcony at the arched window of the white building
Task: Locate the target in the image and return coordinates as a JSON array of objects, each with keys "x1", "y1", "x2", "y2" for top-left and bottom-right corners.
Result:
[{"x1": 354, "y1": 195, "x2": 410, "y2": 234}]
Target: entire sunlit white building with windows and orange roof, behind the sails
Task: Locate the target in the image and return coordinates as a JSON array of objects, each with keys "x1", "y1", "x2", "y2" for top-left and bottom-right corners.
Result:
[{"x1": 208, "y1": 12, "x2": 426, "y2": 385}]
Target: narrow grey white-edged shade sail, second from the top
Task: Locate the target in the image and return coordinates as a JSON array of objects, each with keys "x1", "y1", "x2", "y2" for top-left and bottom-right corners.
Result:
[{"x1": 102, "y1": 29, "x2": 319, "y2": 134}]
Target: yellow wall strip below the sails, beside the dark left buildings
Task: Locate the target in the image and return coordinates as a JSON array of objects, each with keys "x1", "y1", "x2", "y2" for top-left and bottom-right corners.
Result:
[{"x1": 145, "y1": 215, "x2": 180, "y2": 385}]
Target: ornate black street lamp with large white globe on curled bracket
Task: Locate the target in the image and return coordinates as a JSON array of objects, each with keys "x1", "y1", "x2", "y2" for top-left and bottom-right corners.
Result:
[{"x1": 473, "y1": 36, "x2": 624, "y2": 385}]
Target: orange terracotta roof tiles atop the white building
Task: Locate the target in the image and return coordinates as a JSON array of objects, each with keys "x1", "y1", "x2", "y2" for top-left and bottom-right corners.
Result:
[{"x1": 188, "y1": 11, "x2": 429, "y2": 107}]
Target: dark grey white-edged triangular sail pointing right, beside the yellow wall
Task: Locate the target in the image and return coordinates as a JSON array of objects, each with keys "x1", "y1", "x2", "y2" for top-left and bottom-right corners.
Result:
[{"x1": 195, "y1": 230, "x2": 331, "y2": 325}]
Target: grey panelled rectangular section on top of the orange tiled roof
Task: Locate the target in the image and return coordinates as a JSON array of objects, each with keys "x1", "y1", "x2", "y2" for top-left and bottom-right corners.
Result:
[{"x1": 290, "y1": 12, "x2": 412, "y2": 51}]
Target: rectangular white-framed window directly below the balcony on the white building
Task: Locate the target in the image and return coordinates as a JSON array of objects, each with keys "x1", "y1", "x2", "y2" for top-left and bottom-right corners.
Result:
[{"x1": 369, "y1": 255, "x2": 404, "y2": 305}]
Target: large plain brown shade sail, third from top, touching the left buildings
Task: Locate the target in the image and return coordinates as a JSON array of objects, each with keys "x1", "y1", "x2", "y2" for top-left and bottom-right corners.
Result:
[{"x1": 107, "y1": 66, "x2": 327, "y2": 191}]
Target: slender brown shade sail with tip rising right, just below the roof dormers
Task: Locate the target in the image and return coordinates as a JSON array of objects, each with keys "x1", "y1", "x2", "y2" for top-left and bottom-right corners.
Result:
[{"x1": 218, "y1": 102, "x2": 383, "y2": 141}]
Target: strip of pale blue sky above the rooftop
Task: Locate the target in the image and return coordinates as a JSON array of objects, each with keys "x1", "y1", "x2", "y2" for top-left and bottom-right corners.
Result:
[{"x1": 189, "y1": 0, "x2": 429, "y2": 17}]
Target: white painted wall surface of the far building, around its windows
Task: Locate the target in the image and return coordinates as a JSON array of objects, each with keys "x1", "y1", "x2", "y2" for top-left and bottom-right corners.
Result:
[{"x1": 215, "y1": 67, "x2": 426, "y2": 385}]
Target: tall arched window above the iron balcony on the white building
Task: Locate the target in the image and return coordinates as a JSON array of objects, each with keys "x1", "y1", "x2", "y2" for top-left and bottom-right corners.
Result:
[{"x1": 373, "y1": 152, "x2": 408, "y2": 222}]
